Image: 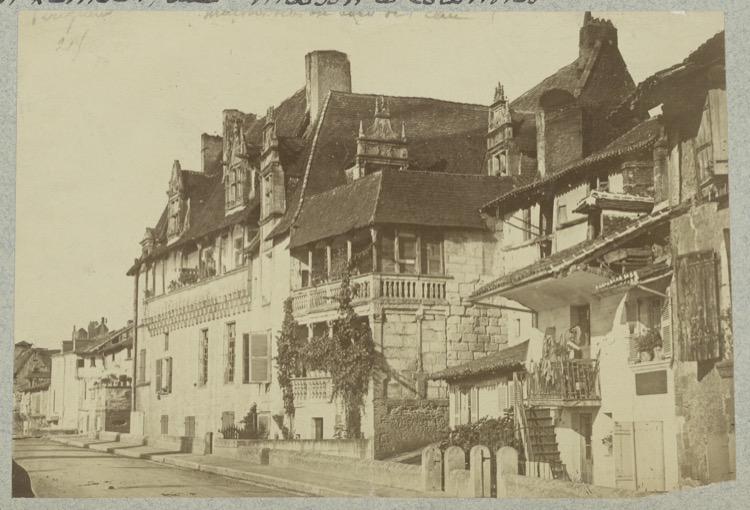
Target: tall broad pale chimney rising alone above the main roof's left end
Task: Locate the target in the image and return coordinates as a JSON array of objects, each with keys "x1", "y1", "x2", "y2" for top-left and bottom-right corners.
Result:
[{"x1": 305, "y1": 50, "x2": 352, "y2": 123}]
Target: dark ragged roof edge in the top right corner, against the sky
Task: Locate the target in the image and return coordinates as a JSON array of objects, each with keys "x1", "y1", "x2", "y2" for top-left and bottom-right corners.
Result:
[{"x1": 611, "y1": 30, "x2": 725, "y2": 117}]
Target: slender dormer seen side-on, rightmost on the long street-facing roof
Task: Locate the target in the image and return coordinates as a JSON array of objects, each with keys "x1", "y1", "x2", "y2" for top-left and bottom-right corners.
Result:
[{"x1": 260, "y1": 107, "x2": 286, "y2": 222}]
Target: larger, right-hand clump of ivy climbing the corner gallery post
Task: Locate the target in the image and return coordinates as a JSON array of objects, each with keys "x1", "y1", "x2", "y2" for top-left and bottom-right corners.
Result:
[{"x1": 301, "y1": 263, "x2": 375, "y2": 439}]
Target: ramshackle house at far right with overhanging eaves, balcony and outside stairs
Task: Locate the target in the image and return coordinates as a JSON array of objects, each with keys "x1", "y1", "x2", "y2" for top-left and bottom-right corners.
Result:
[{"x1": 435, "y1": 29, "x2": 734, "y2": 491}]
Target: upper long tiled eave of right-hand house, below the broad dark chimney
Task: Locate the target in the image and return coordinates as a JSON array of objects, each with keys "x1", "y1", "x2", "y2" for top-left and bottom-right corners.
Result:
[{"x1": 482, "y1": 117, "x2": 662, "y2": 213}]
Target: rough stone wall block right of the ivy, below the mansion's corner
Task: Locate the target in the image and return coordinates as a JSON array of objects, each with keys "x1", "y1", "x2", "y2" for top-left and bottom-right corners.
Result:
[{"x1": 373, "y1": 399, "x2": 450, "y2": 459}]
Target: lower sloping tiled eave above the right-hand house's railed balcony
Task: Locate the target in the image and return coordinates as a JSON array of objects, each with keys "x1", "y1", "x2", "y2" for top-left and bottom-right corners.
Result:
[{"x1": 471, "y1": 202, "x2": 690, "y2": 298}]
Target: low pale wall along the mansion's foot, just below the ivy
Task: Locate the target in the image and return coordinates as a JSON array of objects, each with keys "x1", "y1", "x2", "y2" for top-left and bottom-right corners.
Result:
[{"x1": 213, "y1": 439, "x2": 372, "y2": 459}]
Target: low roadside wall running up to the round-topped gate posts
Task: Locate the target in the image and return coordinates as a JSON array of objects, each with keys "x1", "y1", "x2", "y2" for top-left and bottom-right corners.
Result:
[{"x1": 268, "y1": 450, "x2": 422, "y2": 490}]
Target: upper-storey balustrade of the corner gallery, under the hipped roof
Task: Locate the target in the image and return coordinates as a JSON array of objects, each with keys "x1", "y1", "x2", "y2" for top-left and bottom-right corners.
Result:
[{"x1": 292, "y1": 274, "x2": 447, "y2": 314}]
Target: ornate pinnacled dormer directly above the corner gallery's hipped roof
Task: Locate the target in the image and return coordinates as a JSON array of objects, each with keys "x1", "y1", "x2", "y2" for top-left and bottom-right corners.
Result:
[{"x1": 346, "y1": 96, "x2": 409, "y2": 180}]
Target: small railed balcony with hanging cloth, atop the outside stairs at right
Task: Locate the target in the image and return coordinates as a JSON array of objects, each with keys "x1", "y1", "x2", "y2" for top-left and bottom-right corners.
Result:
[{"x1": 526, "y1": 359, "x2": 601, "y2": 407}]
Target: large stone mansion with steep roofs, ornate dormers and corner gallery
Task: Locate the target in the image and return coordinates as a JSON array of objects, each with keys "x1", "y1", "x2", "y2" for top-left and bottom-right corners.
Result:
[{"x1": 128, "y1": 11, "x2": 664, "y2": 456}]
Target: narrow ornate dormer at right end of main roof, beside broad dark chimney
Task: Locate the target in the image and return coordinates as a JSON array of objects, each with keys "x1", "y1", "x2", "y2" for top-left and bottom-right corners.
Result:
[{"x1": 487, "y1": 83, "x2": 517, "y2": 176}]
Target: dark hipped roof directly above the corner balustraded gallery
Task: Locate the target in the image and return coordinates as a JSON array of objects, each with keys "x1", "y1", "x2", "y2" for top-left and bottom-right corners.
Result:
[{"x1": 289, "y1": 169, "x2": 516, "y2": 248}]
